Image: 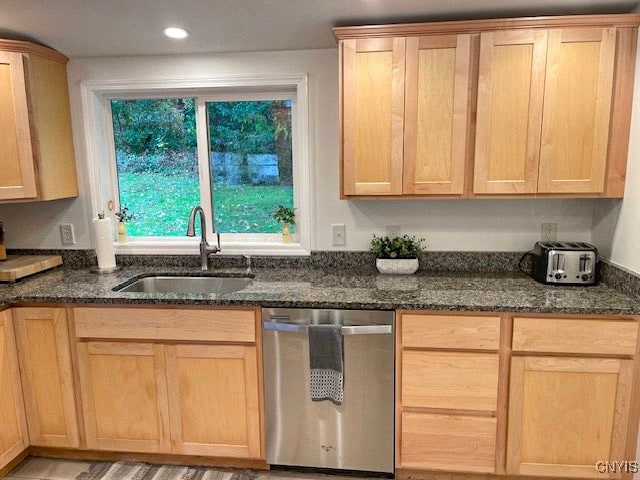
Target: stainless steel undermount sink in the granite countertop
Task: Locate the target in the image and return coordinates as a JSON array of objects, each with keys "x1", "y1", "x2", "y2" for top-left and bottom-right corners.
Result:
[{"x1": 114, "y1": 275, "x2": 251, "y2": 294}]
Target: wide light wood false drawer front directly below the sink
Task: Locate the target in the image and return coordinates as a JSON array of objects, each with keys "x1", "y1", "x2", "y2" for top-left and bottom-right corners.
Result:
[{"x1": 74, "y1": 308, "x2": 256, "y2": 343}]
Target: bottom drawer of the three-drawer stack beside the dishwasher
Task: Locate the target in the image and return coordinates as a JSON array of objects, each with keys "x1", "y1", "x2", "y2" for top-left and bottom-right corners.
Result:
[{"x1": 400, "y1": 413, "x2": 496, "y2": 473}]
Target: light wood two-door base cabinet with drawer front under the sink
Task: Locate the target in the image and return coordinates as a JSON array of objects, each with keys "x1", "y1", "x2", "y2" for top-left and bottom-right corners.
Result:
[{"x1": 74, "y1": 308, "x2": 264, "y2": 459}]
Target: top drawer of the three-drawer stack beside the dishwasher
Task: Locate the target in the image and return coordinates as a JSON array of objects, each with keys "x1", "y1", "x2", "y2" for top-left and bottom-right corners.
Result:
[{"x1": 402, "y1": 314, "x2": 500, "y2": 351}]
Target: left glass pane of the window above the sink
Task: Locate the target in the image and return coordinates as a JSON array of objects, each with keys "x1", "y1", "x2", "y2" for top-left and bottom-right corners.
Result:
[{"x1": 111, "y1": 98, "x2": 200, "y2": 237}]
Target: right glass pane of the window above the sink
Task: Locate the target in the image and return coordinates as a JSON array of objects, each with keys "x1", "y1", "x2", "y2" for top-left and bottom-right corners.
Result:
[{"x1": 207, "y1": 100, "x2": 293, "y2": 233}]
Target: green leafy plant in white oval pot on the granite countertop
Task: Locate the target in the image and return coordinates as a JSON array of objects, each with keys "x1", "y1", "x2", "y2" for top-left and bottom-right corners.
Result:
[{"x1": 369, "y1": 235, "x2": 424, "y2": 274}]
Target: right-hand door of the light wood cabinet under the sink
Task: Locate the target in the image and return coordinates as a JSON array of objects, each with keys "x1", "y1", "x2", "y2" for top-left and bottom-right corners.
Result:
[{"x1": 166, "y1": 345, "x2": 262, "y2": 458}]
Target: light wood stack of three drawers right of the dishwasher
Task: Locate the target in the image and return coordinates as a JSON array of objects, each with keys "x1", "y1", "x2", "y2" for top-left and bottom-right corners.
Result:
[{"x1": 396, "y1": 312, "x2": 500, "y2": 473}]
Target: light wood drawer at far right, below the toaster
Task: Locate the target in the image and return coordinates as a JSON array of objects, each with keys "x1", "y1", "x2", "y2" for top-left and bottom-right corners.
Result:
[{"x1": 513, "y1": 317, "x2": 638, "y2": 355}]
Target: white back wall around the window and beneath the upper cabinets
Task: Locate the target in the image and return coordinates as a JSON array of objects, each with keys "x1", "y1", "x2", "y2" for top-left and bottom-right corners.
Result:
[{"x1": 0, "y1": 49, "x2": 598, "y2": 251}]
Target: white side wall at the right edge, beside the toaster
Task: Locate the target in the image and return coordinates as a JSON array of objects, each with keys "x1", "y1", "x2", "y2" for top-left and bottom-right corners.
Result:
[{"x1": 593, "y1": 33, "x2": 640, "y2": 274}]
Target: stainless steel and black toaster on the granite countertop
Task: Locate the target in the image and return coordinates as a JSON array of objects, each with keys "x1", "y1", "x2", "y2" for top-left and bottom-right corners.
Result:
[{"x1": 531, "y1": 242, "x2": 599, "y2": 285}]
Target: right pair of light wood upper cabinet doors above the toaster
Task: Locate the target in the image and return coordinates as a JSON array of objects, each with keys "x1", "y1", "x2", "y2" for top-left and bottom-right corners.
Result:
[{"x1": 473, "y1": 28, "x2": 616, "y2": 194}]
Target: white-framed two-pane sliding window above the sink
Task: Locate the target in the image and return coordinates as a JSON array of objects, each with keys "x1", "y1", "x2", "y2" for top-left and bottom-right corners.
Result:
[{"x1": 84, "y1": 75, "x2": 310, "y2": 254}]
